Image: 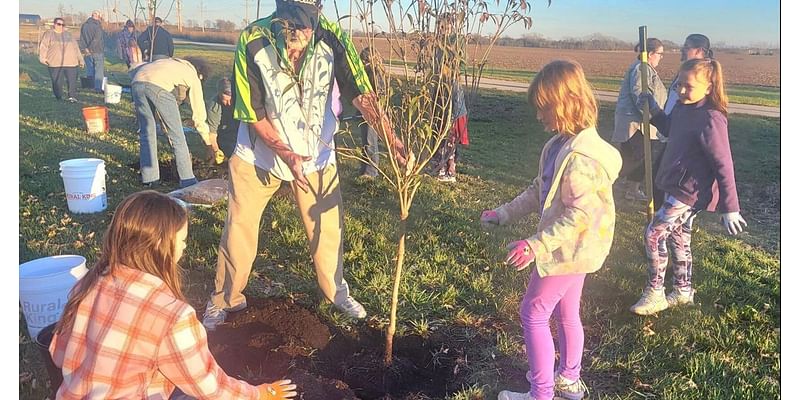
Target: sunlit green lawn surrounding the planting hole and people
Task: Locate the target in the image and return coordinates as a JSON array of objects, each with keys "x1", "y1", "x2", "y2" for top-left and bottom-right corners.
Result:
[{"x1": 19, "y1": 45, "x2": 781, "y2": 400}]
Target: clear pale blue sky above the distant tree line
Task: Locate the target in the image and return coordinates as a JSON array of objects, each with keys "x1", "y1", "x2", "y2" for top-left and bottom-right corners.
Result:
[{"x1": 19, "y1": 0, "x2": 780, "y2": 46}]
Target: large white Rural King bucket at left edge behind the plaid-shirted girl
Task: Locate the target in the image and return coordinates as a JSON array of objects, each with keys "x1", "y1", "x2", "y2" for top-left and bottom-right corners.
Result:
[{"x1": 19, "y1": 255, "x2": 87, "y2": 338}]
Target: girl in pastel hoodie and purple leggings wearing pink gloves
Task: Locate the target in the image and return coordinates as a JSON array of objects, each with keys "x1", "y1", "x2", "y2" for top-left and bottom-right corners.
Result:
[{"x1": 481, "y1": 60, "x2": 622, "y2": 400}]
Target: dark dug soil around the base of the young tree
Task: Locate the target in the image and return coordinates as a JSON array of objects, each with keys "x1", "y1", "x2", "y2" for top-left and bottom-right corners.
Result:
[{"x1": 203, "y1": 298, "x2": 496, "y2": 400}]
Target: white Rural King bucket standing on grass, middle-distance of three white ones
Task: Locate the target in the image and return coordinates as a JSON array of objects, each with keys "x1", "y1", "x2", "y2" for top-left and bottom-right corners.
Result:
[{"x1": 58, "y1": 158, "x2": 108, "y2": 214}]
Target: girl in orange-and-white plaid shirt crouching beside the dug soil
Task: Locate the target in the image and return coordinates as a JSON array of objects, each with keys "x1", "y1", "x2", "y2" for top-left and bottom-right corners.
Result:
[{"x1": 50, "y1": 191, "x2": 297, "y2": 399}]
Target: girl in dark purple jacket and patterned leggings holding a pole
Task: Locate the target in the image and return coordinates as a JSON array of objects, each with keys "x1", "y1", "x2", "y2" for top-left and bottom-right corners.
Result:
[{"x1": 630, "y1": 58, "x2": 747, "y2": 315}]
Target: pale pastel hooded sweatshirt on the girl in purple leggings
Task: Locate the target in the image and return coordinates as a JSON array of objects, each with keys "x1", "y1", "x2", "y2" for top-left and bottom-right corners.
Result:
[{"x1": 495, "y1": 127, "x2": 622, "y2": 277}]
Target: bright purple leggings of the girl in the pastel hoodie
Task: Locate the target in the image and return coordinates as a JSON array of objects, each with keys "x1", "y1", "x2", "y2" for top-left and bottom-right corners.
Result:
[{"x1": 519, "y1": 267, "x2": 586, "y2": 400}]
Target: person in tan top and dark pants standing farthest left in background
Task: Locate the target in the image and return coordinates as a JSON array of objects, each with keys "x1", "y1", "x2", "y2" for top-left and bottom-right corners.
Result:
[{"x1": 39, "y1": 17, "x2": 83, "y2": 103}]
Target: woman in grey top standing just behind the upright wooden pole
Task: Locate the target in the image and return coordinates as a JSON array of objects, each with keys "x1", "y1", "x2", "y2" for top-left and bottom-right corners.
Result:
[{"x1": 611, "y1": 38, "x2": 667, "y2": 201}]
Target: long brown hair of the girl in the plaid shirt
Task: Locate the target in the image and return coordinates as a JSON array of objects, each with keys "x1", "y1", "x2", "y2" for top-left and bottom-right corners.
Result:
[{"x1": 56, "y1": 190, "x2": 188, "y2": 333}]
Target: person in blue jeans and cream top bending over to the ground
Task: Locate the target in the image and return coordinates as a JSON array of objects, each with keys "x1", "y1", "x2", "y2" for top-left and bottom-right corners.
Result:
[{"x1": 131, "y1": 58, "x2": 211, "y2": 188}]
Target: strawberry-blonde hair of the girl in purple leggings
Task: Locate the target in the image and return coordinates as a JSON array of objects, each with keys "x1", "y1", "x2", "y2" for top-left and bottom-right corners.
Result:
[{"x1": 528, "y1": 60, "x2": 597, "y2": 135}]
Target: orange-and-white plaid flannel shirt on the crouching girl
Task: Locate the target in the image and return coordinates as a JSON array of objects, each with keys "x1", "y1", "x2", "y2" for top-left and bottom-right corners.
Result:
[{"x1": 50, "y1": 267, "x2": 259, "y2": 399}]
